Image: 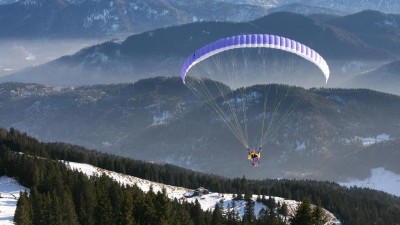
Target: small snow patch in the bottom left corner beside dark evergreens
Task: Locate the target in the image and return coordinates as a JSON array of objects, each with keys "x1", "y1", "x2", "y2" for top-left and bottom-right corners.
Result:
[{"x1": 0, "y1": 176, "x2": 29, "y2": 225}]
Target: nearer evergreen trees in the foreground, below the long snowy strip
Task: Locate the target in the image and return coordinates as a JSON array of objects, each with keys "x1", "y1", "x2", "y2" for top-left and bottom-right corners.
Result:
[{"x1": 0, "y1": 150, "x2": 324, "y2": 225}]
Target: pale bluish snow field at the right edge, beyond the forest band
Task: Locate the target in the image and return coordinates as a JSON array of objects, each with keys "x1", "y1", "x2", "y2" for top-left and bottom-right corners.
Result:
[{"x1": 339, "y1": 167, "x2": 400, "y2": 196}]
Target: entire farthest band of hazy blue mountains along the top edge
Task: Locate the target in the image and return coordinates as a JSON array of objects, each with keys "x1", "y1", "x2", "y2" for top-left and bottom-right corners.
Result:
[{"x1": 0, "y1": 0, "x2": 400, "y2": 38}]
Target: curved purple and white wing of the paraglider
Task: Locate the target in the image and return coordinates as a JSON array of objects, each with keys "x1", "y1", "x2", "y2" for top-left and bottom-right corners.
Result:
[{"x1": 181, "y1": 34, "x2": 330, "y2": 83}]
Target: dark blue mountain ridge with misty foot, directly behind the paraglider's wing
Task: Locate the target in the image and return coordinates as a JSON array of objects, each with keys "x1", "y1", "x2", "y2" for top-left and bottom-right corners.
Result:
[{"x1": 0, "y1": 11, "x2": 400, "y2": 93}]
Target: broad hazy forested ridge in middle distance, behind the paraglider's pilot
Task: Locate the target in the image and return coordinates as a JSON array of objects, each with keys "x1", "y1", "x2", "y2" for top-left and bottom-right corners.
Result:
[{"x1": 0, "y1": 77, "x2": 400, "y2": 180}]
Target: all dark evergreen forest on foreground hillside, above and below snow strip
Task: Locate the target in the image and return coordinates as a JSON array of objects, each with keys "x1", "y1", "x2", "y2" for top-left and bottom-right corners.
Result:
[{"x1": 0, "y1": 129, "x2": 400, "y2": 224}]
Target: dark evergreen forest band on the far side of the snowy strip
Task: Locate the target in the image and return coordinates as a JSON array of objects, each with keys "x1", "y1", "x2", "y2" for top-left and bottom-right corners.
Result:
[{"x1": 0, "y1": 129, "x2": 400, "y2": 224}]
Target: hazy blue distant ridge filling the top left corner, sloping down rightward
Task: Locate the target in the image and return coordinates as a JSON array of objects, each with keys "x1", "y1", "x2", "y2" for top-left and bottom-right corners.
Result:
[{"x1": 0, "y1": 0, "x2": 266, "y2": 39}]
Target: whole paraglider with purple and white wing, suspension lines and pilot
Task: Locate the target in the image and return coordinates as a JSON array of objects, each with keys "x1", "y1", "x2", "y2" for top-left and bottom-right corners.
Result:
[{"x1": 180, "y1": 34, "x2": 330, "y2": 166}]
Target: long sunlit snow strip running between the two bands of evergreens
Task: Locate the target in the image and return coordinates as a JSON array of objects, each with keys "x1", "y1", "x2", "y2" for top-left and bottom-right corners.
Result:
[{"x1": 66, "y1": 162, "x2": 341, "y2": 225}]
